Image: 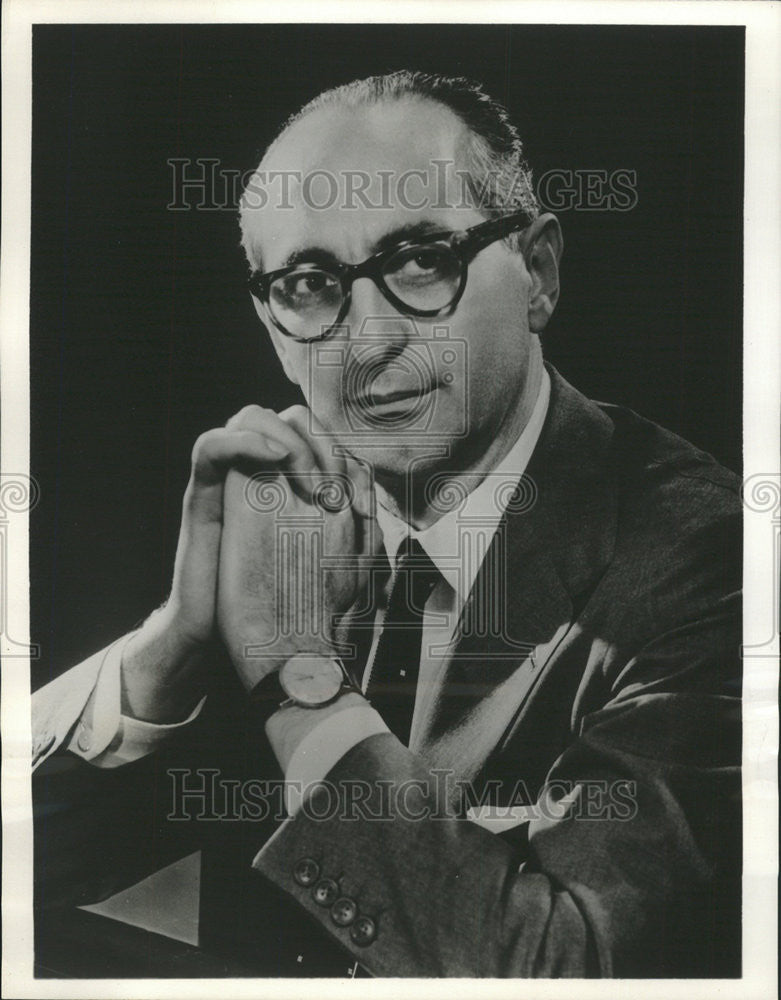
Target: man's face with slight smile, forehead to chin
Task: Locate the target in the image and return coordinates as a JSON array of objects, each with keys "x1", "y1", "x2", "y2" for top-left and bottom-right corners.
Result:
[{"x1": 245, "y1": 100, "x2": 544, "y2": 479}]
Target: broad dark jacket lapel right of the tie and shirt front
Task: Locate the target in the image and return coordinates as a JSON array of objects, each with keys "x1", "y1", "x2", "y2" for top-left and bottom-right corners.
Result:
[{"x1": 412, "y1": 368, "x2": 616, "y2": 780}]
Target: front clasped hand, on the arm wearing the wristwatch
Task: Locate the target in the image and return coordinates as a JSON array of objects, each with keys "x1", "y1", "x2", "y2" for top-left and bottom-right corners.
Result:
[{"x1": 217, "y1": 407, "x2": 371, "y2": 688}]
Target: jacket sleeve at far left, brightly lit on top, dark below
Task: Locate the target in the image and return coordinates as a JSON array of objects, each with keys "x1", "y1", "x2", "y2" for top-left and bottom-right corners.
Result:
[{"x1": 32, "y1": 639, "x2": 207, "y2": 911}]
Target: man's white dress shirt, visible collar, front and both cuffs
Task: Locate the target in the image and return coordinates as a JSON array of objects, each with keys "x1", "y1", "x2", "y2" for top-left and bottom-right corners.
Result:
[{"x1": 68, "y1": 370, "x2": 550, "y2": 815}]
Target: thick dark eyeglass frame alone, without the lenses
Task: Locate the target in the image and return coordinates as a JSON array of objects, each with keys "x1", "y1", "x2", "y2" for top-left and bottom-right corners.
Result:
[{"x1": 247, "y1": 211, "x2": 534, "y2": 344}]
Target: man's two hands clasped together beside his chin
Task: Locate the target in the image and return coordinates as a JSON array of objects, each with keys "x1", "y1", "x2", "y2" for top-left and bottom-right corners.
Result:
[{"x1": 122, "y1": 406, "x2": 379, "y2": 722}]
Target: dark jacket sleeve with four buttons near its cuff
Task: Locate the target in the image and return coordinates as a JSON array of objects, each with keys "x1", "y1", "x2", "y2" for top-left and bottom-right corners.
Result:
[{"x1": 254, "y1": 595, "x2": 741, "y2": 977}]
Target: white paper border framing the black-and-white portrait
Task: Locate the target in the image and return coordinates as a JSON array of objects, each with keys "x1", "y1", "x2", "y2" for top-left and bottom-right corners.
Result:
[{"x1": 0, "y1": 0, "x2": 781, "y2": 1000}]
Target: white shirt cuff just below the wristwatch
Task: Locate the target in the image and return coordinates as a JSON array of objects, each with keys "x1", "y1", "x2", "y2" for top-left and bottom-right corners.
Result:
[{"x1": 285, "y1": 705, "x2": 389, "y2": 816}]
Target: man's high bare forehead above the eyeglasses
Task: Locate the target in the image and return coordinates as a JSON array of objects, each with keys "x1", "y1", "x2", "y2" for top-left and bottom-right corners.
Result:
[{"x1": 244, "y1": 99, "x2": 481, "y2": 270}]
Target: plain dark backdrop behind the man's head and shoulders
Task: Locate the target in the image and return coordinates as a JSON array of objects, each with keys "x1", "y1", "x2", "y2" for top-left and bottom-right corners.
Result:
[{"x1": 30, "y1": 25, "x2": 743, "y2": 685}]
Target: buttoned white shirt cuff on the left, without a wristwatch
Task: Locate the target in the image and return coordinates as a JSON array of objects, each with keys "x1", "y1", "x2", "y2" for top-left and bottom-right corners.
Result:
[{"x1": 68, "y1": 632, "x2": 206, "y2": 768}]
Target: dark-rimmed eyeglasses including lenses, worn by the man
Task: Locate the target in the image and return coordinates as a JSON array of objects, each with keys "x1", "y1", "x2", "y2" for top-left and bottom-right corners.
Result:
[{"x1": 249, "y1": 212, "x2": 532, "y2": 342}]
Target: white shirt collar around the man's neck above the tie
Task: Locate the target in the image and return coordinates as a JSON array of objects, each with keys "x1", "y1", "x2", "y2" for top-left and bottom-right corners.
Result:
[{"x1": 377, "y1": 369, "x2": 550, "y2": 603}]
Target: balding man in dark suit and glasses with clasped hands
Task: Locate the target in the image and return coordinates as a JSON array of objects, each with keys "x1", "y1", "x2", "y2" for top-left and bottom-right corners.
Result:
[{"x1": 34, "y1": 73, "x2": 740, "y2": 976}]
